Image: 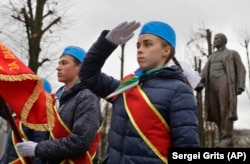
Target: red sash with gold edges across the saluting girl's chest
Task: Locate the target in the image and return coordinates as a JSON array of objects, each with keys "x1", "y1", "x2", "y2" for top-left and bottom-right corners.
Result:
[{"x1": 123, "y1": 86, "x2": 171, "y2": 163}]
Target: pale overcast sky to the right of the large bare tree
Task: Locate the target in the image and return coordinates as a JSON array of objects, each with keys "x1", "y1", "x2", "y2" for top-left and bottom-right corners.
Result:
[{"x1": 2, "y1": 0, "x2": 250, "y2": 129}]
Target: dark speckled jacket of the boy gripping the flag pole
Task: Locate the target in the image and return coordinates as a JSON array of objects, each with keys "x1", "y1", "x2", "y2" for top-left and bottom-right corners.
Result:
[{"x1": 35, "y1": 83, "x2": 101, "y2": 164}]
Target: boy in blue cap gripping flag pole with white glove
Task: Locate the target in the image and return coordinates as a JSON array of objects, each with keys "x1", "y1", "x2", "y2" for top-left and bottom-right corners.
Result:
[{"x1": 16, "y1": 46, "x2": 102, "y2": 164}]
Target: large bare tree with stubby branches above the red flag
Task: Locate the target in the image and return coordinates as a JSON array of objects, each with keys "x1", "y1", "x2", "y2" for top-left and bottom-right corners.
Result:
[{"x1": 0, "y1": 0, "x2": 71, "y2": 73}]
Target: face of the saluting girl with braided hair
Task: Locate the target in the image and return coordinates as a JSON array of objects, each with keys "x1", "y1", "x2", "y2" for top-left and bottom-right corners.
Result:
[{"x1": 137, "y1": 34, "x2": 171, "y2": 70}]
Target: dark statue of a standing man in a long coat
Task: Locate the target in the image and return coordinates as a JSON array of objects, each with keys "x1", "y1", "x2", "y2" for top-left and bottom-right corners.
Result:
[{"x1": 195, "y1": 33, "x2": 246, "y2": 147}]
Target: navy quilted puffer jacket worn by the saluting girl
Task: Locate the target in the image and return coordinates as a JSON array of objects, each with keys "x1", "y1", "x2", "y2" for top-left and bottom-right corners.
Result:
[{"x1": 79, "y1": 31, "x2": 199, "y2": 164}]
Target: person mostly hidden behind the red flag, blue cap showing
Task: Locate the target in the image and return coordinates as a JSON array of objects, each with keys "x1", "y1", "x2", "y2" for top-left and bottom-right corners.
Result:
[{"x1": 0, "y1": 78, "x2": 52, "y2": 164}]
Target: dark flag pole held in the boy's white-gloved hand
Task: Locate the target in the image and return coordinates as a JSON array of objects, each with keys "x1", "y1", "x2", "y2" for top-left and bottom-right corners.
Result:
[{"x1": 0, "y1": 95, "x2": 32, "y2": 164}]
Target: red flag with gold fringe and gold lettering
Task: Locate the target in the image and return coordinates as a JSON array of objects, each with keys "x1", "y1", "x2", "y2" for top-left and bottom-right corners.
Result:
[{"x1": 0, "y1": 43, "x2": 54, "y2": 131}]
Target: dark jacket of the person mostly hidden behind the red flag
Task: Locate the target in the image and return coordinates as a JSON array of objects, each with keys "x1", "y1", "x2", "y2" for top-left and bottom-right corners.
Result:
[{"x1": 0, "y1": 110, "x2": 49, "y2": 164}]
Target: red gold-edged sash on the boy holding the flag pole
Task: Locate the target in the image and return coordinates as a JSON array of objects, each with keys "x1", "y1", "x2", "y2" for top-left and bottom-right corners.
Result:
[{"x1": 51, "y1": 101, "x2": 102, "y2": 164}]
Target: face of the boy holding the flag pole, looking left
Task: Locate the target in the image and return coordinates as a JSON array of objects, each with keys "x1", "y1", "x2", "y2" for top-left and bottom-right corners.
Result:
[{"x1": 56, "y1": 55, "x2": 80, "y2": 85}]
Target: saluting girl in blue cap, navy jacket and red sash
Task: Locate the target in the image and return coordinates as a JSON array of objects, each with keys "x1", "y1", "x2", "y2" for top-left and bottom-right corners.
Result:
[{"x1": 79, "y1": 21, "x2": 200, "y2": 164}]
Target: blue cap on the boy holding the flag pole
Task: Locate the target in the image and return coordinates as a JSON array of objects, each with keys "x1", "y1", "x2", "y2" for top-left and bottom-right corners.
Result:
[{"x1": 62, "y1": 46, "x2": 86, "y2": 63}]
